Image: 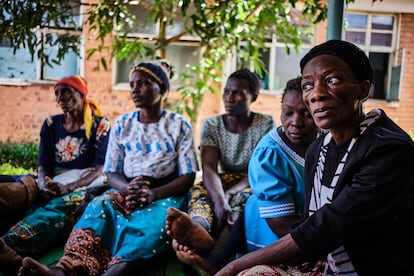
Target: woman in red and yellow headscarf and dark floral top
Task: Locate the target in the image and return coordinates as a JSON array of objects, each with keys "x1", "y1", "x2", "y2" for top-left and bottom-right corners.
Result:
[{"x1": 0, "y1": 76, "x2": 110, "y2": 271}]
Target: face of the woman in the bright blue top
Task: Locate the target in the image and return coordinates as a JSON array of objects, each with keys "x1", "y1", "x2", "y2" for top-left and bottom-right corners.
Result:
[{"x1": 280, "y1": 90, "x2": 319, "y2": 144}]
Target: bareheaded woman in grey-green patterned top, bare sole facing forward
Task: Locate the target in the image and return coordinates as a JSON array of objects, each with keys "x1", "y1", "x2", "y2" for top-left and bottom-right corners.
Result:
[{"x1": 166, "y1": 69, "x2": 275, "y2": 262}]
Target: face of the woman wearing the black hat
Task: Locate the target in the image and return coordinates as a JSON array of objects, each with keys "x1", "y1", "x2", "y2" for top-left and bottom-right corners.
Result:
[{"x1": 302, "y1": 55, "x2": 369, "y2": 129}]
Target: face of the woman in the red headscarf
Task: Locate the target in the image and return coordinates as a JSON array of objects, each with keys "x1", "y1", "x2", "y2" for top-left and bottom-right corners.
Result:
[{"x1": 55, "y1": 84, "x2": 83, "y2": 113}]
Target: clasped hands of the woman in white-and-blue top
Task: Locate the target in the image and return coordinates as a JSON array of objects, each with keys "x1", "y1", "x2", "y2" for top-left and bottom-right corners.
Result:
[{"x1": 110, "y1": 176, "x2": 154, "y2": 214}]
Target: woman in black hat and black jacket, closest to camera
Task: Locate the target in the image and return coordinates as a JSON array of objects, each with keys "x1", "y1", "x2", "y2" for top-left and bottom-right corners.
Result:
[{"x1": 217, "y1": 40, "x2": 414, "y2": 275}]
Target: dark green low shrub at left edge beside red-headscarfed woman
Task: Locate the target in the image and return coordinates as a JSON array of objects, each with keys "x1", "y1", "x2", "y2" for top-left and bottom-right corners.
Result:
[{"x1": 0, "y1": 141, "x2": 39, "y2": 171}]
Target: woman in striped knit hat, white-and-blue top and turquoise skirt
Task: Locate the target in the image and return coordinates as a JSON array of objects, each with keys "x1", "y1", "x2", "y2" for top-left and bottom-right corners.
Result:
[{"x1": 21, "y1": 61, "x2": 198, "y2": 275}]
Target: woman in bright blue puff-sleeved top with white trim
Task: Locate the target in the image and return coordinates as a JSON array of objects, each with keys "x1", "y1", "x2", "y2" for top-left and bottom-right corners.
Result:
[{"x1": 245, "y1": 77, "x2": 318, "y2": 251}]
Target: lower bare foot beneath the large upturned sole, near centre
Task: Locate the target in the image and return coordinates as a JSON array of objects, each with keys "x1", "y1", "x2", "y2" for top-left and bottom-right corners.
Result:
[{"x1": 173, "y1": 239, "x2": 214, "y2": 276}]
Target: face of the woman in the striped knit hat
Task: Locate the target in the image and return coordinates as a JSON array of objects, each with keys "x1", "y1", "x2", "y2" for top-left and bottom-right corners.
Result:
[{"x1": 129, "y1": 71, "x2": 163, "y2": 108}]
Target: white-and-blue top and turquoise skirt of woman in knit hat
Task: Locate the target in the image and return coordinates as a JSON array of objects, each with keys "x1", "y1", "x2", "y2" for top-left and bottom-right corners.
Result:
[{"x1": 60, "y1": 110, "x2": 198, "y2": 273}]
